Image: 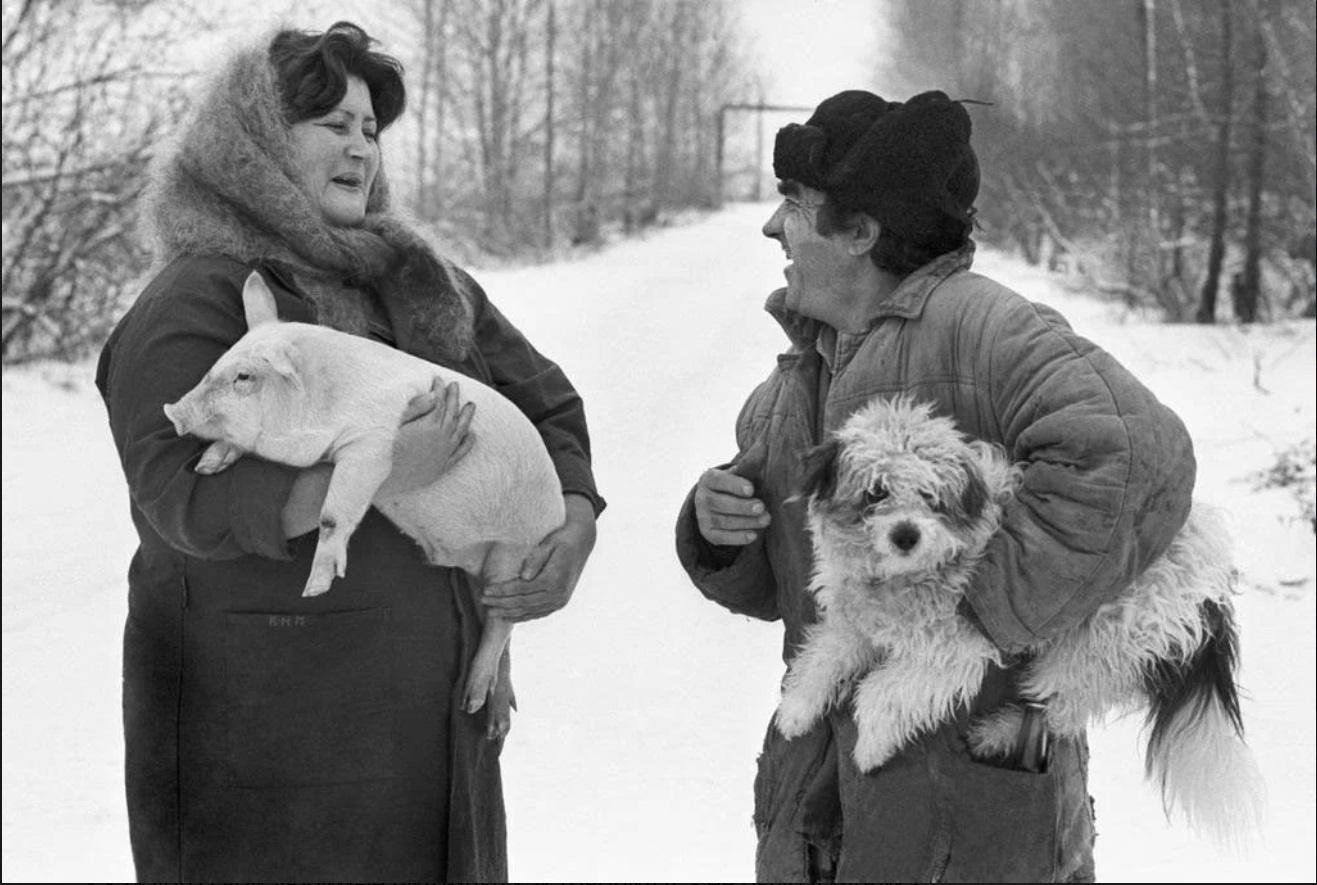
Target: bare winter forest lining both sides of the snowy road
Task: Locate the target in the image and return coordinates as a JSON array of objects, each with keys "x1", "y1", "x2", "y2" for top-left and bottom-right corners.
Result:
[{"x1": 3, "y1": 0, "x2": 1317, "y2": 365}]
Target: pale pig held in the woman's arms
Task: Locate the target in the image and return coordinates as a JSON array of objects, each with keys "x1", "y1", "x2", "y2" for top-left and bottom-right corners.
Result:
[{"x1": 165, "y1": 273, "x2": 566, "y2": 739}]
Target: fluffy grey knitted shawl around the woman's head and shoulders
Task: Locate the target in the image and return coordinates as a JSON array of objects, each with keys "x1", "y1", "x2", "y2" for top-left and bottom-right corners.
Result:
[{"x1": 144, "y1": 34, "x2": 473, "y2": 362}]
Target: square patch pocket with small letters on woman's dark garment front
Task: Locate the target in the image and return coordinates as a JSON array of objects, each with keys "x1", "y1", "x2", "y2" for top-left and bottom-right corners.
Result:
[{"x1": 224, "y1": 608, "x2": 395, "y2": 786}]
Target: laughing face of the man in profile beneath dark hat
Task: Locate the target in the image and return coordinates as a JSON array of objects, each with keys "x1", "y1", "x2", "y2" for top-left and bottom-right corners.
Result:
[{"x1": 764, "y1": 180, "x2": 855, "y2": 327}]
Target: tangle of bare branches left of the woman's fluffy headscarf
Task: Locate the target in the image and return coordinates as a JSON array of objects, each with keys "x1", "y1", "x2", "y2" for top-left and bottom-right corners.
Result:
[{"x1": 0, "y1": 0, "x2": 200, "y2": 363}]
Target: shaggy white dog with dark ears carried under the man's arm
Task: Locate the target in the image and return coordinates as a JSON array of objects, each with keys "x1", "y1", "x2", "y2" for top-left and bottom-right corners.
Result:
[{"x1": 776, "y1": 398, "x2": 1260, "y2": 842}]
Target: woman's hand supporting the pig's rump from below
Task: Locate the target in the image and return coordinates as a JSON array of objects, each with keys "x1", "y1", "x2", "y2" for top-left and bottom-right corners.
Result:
[{"x1": 481, "y1": 494, "x2": 595, "y2": 623}]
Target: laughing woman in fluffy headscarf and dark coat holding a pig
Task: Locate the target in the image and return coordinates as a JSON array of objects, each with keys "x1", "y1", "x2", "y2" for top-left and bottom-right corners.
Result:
[{"x1": 97, "y1": 22, "x2": 603, "y2": 881}]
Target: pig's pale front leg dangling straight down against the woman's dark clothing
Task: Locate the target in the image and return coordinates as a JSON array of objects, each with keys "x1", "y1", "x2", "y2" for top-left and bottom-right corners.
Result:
[{"x1": 302, "y1": 439, "x2": 392, "y2": 597}]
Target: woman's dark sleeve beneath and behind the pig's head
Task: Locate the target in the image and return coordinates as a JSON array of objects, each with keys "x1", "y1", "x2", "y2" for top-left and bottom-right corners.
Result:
[{"x1": 96, "y1": 262, "x2": 298, "y2": 560}]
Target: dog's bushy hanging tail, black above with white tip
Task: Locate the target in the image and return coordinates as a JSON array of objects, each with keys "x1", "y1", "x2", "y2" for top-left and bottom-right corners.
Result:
[{"x1": 1143, "y1": 599, "x2": 1266, "y2": 845}]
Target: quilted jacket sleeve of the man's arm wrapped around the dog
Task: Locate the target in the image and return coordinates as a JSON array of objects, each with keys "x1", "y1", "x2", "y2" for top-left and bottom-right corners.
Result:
[{"x1": 967, "y1": 299, "x2": 1196, "y2": 651}]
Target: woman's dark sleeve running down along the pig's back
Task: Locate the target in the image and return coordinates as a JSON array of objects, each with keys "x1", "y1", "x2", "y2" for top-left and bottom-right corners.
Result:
[{"x1": 457, "y1": 270, "x2": 606, "y2": 516}]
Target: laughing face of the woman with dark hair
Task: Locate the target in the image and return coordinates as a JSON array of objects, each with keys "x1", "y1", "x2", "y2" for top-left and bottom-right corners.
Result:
[{"x1": 291, "y1": 76, "x2": 379, "y2": 225}]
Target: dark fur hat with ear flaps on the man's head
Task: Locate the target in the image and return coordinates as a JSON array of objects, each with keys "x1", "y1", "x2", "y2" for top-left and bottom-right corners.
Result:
[{"x1": 773, "y1": 90, "x2": 979, "y2": 241}]
